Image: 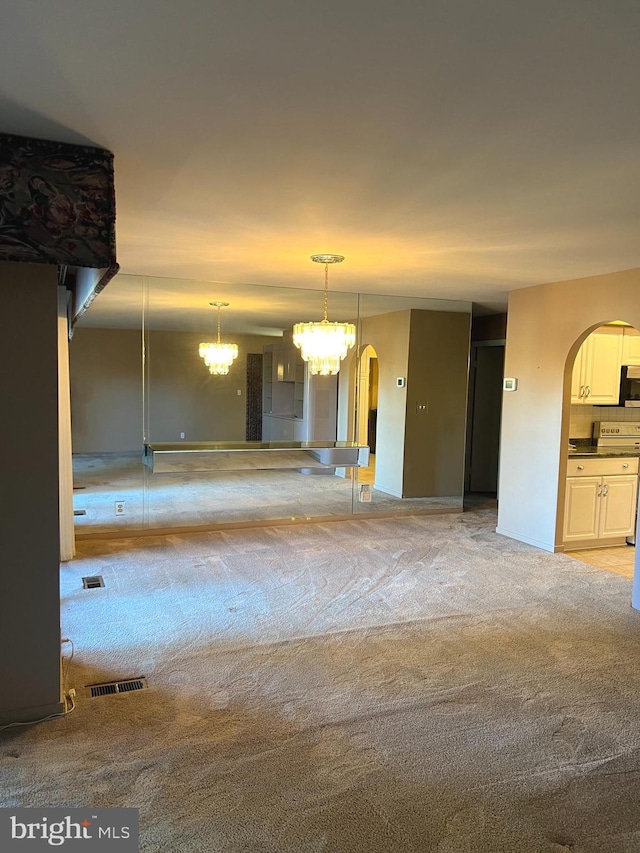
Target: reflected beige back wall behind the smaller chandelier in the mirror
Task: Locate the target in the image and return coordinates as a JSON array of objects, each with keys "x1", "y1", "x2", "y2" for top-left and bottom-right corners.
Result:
[{"x1": 71, "y1": 329, "x2": 274, "y2": 453}]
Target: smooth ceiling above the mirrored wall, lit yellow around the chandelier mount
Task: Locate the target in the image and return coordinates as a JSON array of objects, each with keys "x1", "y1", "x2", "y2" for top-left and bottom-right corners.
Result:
[{"x1": 0, "y1": 0, "x2": 640, "y2": 311}]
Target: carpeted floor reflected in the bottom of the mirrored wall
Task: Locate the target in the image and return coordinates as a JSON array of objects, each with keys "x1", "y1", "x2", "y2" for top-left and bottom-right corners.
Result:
[{"x1": 73, "y1": 453, "x2": 462, "y2": 534}]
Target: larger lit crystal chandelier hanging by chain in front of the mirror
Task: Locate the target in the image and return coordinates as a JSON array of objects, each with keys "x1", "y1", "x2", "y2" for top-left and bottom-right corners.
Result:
[{"x1": 293, "y1": 255, "x2": 356, "y2": 376}]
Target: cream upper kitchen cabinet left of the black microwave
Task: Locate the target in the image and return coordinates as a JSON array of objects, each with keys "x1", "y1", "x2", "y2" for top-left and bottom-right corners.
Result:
[{"x1": 571, "y1": 326, "x2": 624, "y2": 406}]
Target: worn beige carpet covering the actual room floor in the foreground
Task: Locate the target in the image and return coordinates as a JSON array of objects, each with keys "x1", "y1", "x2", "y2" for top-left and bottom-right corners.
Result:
[{"x1": 0, "y1": 510, "x2": 640, "y2": 853}]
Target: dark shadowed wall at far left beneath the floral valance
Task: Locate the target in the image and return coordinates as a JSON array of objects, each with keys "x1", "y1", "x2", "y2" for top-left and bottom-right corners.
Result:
[{"x1": 0, "y1": 262, "x2": 62, "y2": 724}]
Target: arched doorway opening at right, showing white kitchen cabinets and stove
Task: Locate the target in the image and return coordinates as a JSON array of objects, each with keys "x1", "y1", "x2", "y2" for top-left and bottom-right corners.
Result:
[{"x1": 558, "y1": 320, "x2": 640, "y2": 560}]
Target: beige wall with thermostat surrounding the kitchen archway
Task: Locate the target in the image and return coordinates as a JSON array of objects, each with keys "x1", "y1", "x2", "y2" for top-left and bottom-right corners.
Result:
[{"x1": 497, "y1": 269, "x2": 640, "y2": 551}]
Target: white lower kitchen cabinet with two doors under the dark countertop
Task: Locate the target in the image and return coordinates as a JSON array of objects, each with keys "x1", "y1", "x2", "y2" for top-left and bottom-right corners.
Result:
[{"x1": 563, "y1": 457, "x2": 638, "y2": 545}]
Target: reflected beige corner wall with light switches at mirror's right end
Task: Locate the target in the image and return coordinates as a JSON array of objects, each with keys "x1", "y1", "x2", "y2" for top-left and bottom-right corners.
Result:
[{"x1": 350, "y1": 309, "x2": 471, "y2": 498}]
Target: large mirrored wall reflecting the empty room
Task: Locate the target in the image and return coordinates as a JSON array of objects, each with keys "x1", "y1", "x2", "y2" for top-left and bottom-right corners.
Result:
[{"x1": 70, "y1": 275, "x2": 471, "y2": 535}]
